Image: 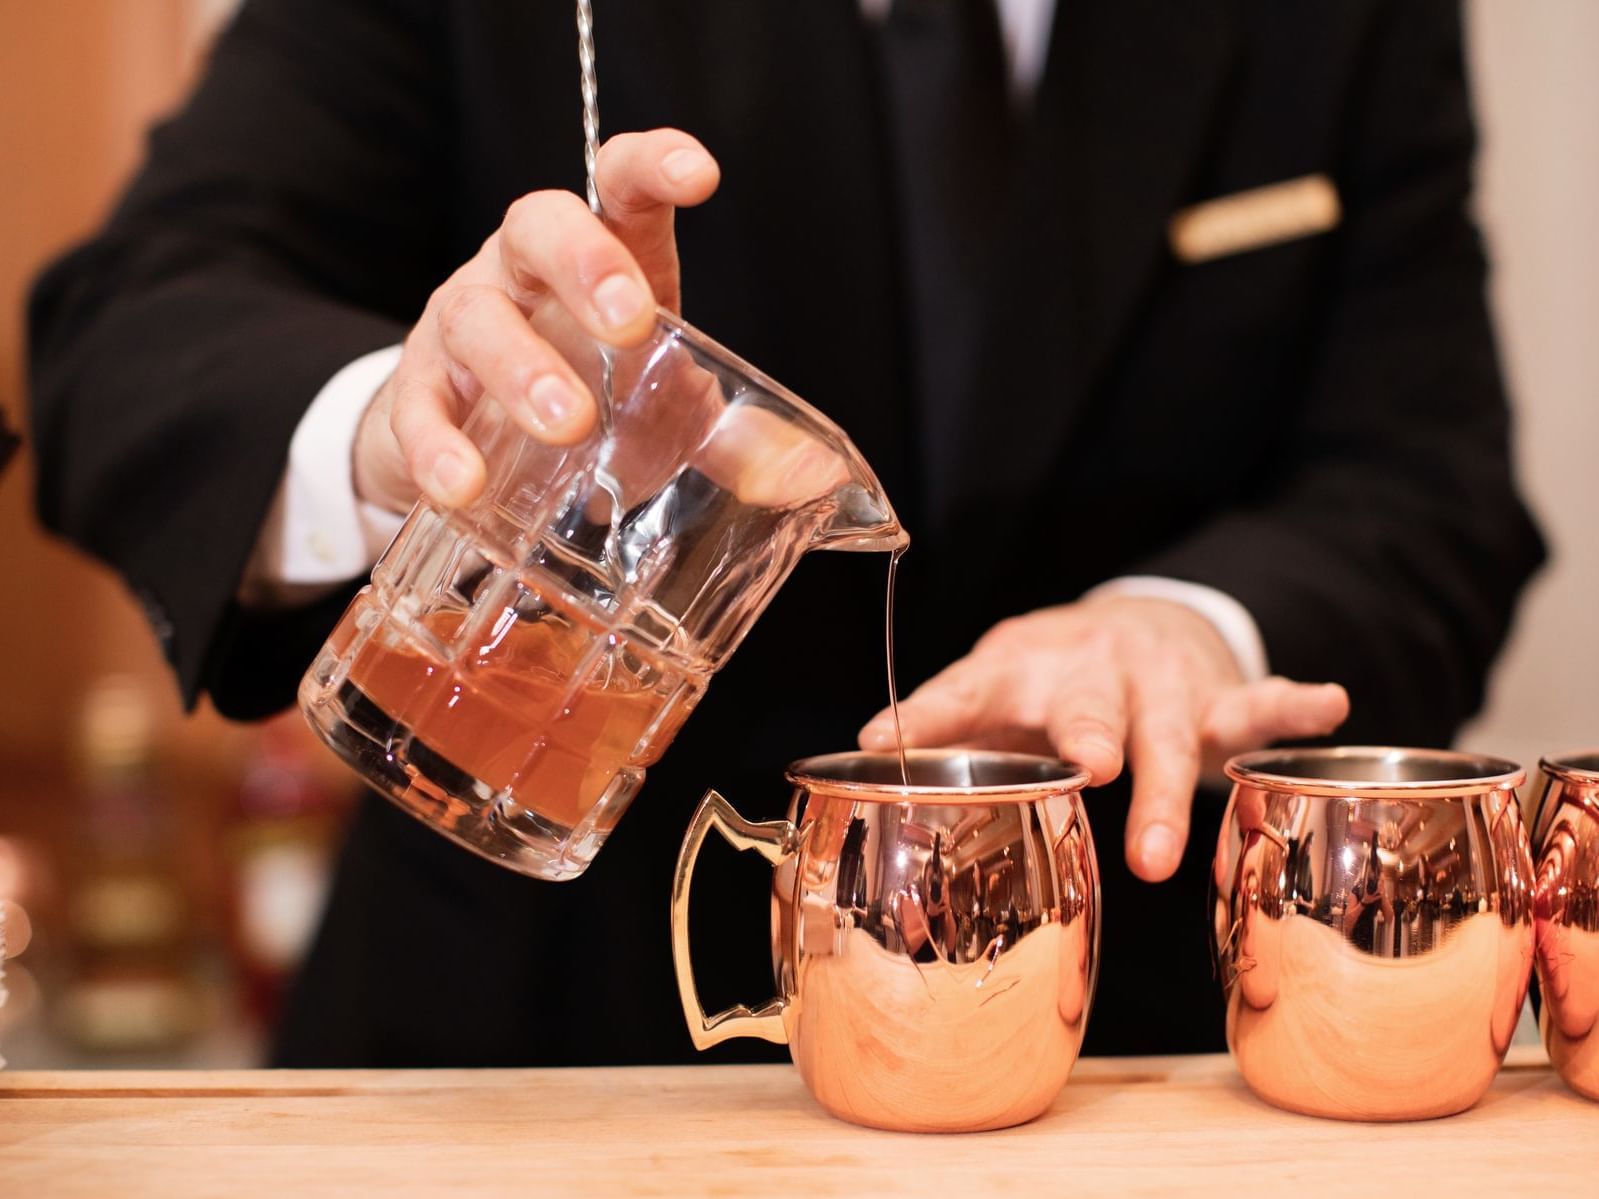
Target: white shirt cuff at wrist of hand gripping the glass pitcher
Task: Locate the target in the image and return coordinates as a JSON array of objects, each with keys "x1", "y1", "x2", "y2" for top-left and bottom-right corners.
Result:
[{"x1": 238, "y1": 345, "x2": 405, "y2": 607}]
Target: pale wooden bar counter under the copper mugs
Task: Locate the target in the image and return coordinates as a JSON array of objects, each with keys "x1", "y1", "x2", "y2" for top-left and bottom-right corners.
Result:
[{"x1": 0, "y1": 1047, "x2": 1599, "y2": 1199}]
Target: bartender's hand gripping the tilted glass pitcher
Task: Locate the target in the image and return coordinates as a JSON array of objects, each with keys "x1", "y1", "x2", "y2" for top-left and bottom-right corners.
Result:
[{"x1": 353, "y1": 129, "x2": 721, "y2": 512}]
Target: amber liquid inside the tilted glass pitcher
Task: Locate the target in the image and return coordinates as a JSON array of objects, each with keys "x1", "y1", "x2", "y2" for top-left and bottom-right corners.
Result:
[{"x1": 318, "y1": 572, "x2": 704, "y2": 863}]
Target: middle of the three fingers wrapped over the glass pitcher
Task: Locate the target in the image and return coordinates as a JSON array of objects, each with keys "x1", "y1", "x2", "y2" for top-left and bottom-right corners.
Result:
[{"x1": 438, "y1": 285, "x2": 596, "y2": 446}]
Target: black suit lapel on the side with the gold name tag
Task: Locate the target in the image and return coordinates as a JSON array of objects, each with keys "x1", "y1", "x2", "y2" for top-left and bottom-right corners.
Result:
[{"x1": 932, "y1": 0, "x2": 1238, "y2": 523}]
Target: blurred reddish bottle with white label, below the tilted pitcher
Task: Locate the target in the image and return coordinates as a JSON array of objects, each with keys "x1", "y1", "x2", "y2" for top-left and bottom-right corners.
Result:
[{"x1": 229, "y1": 713, "x2": 341, "y2": 1026}]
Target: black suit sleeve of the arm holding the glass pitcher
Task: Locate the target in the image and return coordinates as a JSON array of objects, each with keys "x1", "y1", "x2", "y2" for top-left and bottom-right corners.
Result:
[{"x1": 29, "y1": 0, "x2": 448, "y2": 715}]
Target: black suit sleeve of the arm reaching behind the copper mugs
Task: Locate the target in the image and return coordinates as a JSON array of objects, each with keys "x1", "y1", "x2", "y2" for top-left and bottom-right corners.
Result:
[{"x1": 1138, "y1": 0, "x2": 1543, "y2": 745}]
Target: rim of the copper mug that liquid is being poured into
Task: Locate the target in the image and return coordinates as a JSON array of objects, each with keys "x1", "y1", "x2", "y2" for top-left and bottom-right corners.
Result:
[{"x1": 784, "y1": 748, "x2": 1089, "y2": 804}]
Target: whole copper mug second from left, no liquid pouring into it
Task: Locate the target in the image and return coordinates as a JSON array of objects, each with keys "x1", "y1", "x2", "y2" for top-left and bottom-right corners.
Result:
[{"x1": 1210, "y1": 748, "x2": 1532, "y2": 1121}]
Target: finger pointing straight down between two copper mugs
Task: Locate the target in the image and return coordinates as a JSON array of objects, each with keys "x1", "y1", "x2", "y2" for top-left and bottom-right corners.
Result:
[{"x1": 1127, "y1": 683, "x2": 1199, "y2": 882}]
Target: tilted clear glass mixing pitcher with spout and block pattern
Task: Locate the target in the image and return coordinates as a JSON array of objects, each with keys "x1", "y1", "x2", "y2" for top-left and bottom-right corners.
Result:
[{"x1": 299, "y1": 301, "x2": 905, "y2": 879}]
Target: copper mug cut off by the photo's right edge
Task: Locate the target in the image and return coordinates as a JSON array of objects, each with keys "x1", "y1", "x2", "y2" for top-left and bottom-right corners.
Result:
[{"x1": 1532, "y1": 750, "x2": 1599, "y2": 1098}]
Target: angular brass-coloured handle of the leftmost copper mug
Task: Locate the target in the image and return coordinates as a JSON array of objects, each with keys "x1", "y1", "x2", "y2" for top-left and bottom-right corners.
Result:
[{"x1": 672, "y1": 791, "x2": 800, "y2": 1049}]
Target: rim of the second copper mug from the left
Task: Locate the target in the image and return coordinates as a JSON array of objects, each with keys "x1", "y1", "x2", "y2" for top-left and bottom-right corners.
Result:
[{"x1": 1223, "y1": 745, "x2": 1527, "y2": 799}]
